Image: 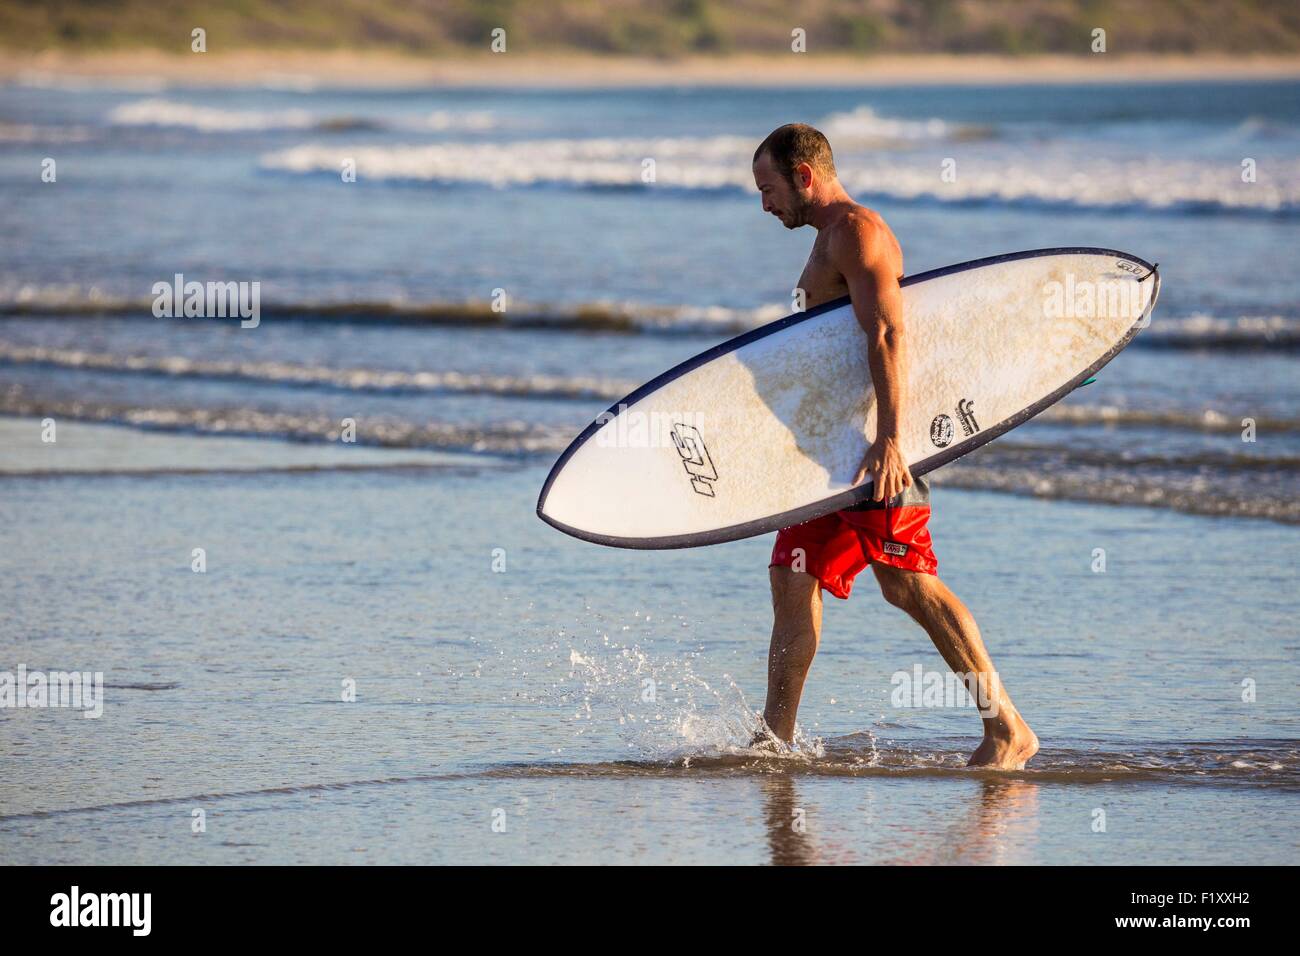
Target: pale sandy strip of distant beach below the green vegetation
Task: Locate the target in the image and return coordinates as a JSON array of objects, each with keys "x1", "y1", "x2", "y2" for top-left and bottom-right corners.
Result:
[{"x1": 0, "y1": 51, "x2": 1300, "y2": 88}]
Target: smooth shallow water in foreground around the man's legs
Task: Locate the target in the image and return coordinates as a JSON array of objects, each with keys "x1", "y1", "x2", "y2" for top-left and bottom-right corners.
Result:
[{"x1": 0, "y1": 419, "x2": 1300, "y2": 862}]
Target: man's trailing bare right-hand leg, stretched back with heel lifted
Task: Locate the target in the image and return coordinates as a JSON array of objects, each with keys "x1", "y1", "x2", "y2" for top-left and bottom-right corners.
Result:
[{"x1": 868, "y1": 562, "x2": 1039, "y2": 770}]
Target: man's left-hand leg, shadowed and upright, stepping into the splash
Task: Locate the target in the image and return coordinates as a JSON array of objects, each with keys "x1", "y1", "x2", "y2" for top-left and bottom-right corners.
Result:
[{"x1": 763, "y1": 567, "x2": 822, "y2": 744}]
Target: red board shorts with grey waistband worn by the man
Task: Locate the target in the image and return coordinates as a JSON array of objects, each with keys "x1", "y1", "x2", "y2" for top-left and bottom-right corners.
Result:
[{"x1": 768, "y1": 479, "x2": 939, "y2": 598}]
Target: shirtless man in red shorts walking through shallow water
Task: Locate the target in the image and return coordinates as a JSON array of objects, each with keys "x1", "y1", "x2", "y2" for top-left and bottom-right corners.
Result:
[{"x1": 754, "y1": 124, "x2": 1039, "y2": 769}]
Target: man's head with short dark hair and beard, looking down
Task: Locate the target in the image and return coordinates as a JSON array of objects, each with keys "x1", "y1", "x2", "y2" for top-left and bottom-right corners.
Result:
[{"x1": 754, "y1": 122, "x2": 837, "y2": 229}]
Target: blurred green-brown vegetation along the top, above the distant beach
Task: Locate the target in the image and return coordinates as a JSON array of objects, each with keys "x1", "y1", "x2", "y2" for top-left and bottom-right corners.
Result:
[{"x1": 0, "y1": 0, "x2": 1300, "y2": 57}]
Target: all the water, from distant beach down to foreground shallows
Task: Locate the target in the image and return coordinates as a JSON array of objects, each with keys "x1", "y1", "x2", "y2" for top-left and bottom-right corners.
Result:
[{"x1": 0, "y1": 81, "x2": 1300, "y2": 864}]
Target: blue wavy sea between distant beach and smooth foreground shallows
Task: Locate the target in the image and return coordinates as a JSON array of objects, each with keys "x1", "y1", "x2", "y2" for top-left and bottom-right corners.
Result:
[{"x1": 0, "y1": 81, "x2": 1300, "y2": 523}]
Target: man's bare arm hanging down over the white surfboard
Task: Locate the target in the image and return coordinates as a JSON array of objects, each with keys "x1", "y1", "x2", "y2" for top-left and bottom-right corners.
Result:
[{"x1": 831, "y1": 222, "x2": 911, "y2": 501}]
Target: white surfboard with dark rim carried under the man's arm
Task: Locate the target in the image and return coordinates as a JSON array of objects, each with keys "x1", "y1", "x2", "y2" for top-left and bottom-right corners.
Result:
[{"x1": 537, "y1": 247, "x2": 1160, "y2": 549}]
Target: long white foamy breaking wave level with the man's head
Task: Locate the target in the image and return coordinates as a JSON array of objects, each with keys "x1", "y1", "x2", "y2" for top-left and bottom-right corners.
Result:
[{"x1": 261, "y1": 128, "x2": 1300, "y2": 216}]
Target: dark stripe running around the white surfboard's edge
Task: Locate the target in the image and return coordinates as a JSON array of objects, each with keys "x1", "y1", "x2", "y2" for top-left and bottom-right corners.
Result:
[{"x1": 537, "y1": 246, "x2": 1160, "y2": 550}]
